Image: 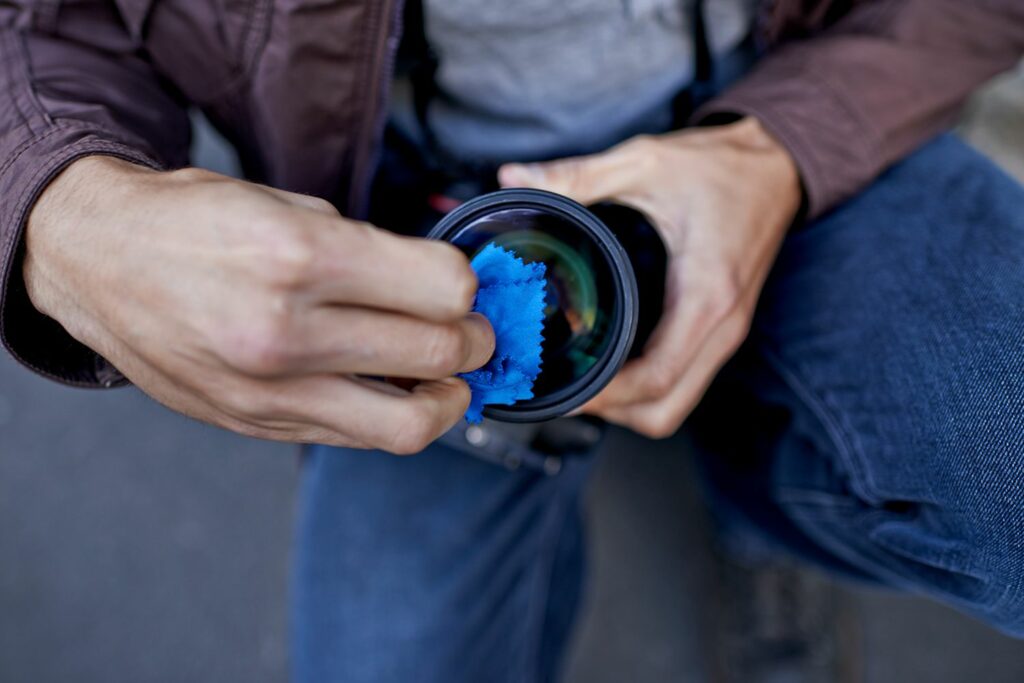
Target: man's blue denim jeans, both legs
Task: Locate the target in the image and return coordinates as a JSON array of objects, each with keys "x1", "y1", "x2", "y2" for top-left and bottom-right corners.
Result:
[{"x1": 292, "y1": 136, "x2": 1024, "y2": 683}]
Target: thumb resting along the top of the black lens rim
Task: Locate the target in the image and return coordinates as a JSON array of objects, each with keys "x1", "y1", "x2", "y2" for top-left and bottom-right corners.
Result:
[{"x1": 498, "y1": 151, "x2": 631, "y2": 204}]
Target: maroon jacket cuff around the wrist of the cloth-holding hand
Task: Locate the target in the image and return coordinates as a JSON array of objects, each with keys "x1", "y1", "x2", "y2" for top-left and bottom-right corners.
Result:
[{"x1": 0, "y1": 122, "x2": 161, "y2": 387}]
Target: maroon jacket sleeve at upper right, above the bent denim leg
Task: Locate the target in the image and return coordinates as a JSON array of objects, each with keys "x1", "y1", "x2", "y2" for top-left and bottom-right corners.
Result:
[{"x1": 694, "y1": 0, "x2": 1024, "y2": 218}]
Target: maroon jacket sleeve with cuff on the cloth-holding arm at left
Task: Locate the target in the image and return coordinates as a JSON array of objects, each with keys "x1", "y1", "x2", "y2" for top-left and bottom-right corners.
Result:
[{"x1": 0, "y1": 0, "x2": 189, "y2": 386}]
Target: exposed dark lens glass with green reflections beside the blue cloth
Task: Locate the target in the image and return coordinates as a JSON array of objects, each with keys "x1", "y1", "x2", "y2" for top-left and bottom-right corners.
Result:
[{"x1": 453, "y1": 208, "x2": 615, "y2": 402}]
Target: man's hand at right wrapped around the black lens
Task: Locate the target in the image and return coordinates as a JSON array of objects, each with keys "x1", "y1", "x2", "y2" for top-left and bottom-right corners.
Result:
[{"x1": 500, "y1": 119, "x2": 801, "y2": 437}]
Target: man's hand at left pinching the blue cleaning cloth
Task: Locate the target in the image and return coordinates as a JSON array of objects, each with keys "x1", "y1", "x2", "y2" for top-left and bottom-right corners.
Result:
[{"x1": 24, "y1": 157, "x2": 495, "y2": 454}]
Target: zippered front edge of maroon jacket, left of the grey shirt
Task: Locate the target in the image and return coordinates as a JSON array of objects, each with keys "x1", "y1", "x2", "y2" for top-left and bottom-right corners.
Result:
[{"x1": 347, "y1": 0, "x2": 403, "y2": 218}]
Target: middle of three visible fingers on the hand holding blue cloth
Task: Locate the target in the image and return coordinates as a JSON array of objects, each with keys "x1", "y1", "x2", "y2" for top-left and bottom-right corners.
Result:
[{"x1": 296, "y1": 306, "x2": 495, "y2": 379}]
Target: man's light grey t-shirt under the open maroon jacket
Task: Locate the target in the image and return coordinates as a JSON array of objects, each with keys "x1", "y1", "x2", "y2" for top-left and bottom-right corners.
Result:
[{"x1": 411, "y1": 0, "x2": 753, "y2": 164}]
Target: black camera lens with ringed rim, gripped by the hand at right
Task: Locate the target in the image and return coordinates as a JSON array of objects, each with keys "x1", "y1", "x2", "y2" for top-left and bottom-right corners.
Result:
[{"x1": 427, "y1": 188, "x2": 666, "y2": 422}]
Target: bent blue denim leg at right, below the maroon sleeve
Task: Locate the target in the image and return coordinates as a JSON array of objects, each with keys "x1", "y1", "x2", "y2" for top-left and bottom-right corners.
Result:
[{"x1": 749, "y1": 136, "x2": 1024, "y2": 636}]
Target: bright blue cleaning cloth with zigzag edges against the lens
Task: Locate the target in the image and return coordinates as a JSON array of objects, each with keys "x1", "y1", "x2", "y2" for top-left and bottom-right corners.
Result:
[{"x1": 461, "y1": 243, "x2": 547, "y2": 422}]
